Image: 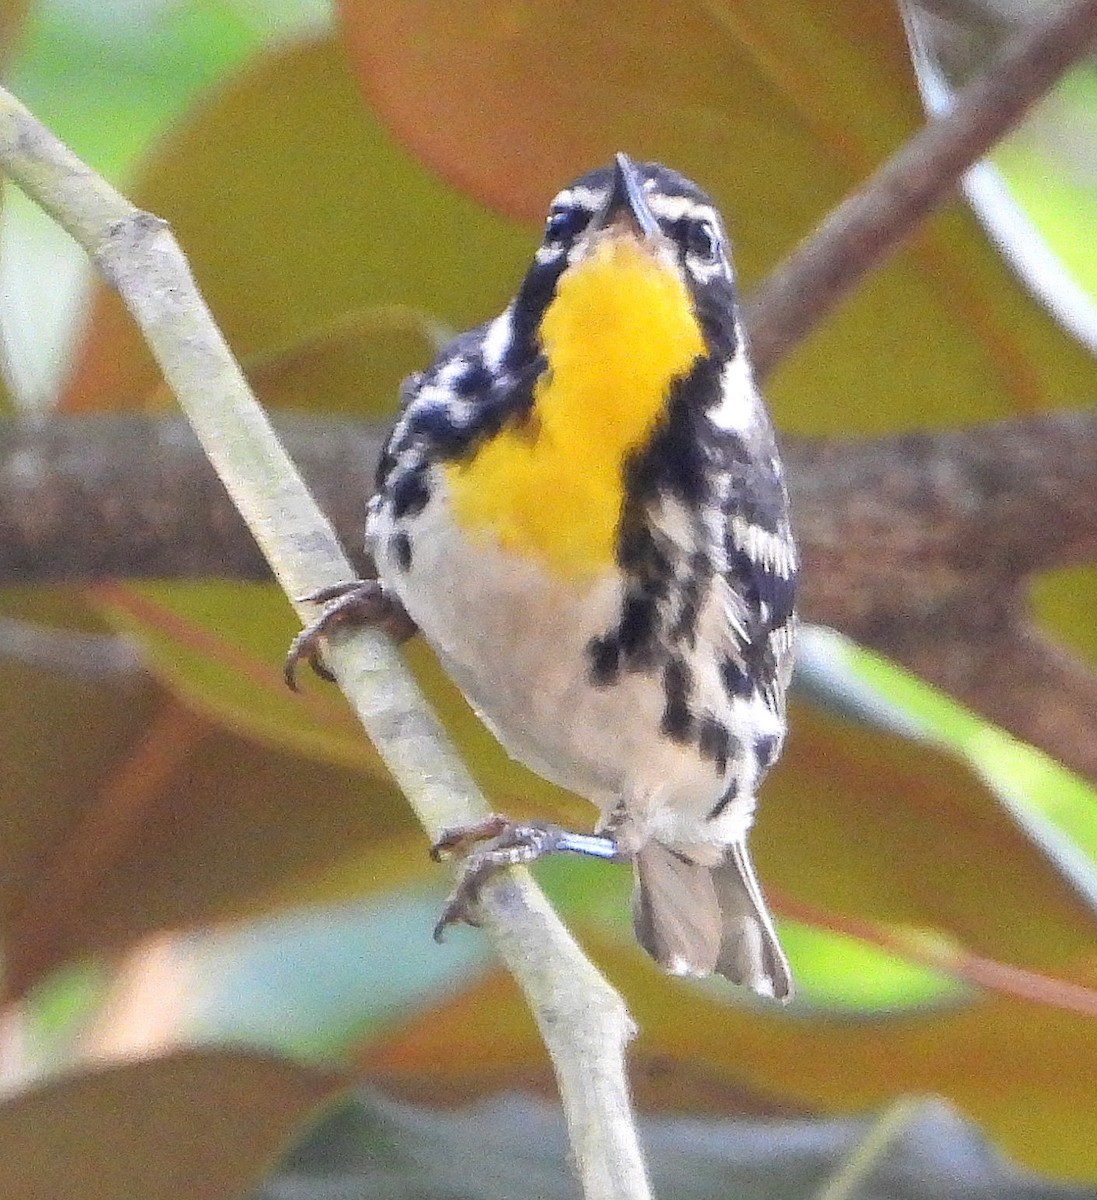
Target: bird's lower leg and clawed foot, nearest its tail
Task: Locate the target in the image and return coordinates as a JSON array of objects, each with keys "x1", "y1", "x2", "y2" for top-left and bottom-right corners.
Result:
[{"x1": 431, "y1": 814, "x2": 628, "y2": 942}]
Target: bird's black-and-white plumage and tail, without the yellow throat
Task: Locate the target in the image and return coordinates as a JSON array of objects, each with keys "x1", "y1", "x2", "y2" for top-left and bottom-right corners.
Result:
[{"x1": 306, "y1": 155, "x2": 797, "y2": 998}]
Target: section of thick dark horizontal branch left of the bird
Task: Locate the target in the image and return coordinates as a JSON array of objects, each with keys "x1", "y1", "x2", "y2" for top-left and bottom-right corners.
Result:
[{"x1": 0, "y1": 415, "x2": 372, "y2": 583}]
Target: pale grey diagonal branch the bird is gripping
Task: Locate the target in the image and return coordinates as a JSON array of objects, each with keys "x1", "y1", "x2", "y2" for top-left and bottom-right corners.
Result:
[{"x1": 0, "y1": 90, "x2": 651, "y2": 1200}]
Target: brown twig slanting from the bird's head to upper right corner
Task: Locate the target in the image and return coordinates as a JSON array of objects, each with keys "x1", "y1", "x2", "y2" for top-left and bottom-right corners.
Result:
[{"x1": 745, "y1": 0, "x2": 1097, "y2": 377}]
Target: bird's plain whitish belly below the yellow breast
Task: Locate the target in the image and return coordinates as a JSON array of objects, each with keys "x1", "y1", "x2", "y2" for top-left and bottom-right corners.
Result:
[{"x1": 370, "y1": 475, "x2": 754, "y2": 845}]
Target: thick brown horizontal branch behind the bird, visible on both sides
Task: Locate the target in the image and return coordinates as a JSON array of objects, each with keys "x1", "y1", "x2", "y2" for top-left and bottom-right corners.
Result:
[{"x1": 0, "y1": 410, "x2": 1097, "y2": 781}]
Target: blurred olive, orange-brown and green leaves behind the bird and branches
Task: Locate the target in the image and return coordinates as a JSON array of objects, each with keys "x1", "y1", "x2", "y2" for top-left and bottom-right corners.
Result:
[{"x1": 0, "y1": 0, "x2": 1097, "y2": 1200}]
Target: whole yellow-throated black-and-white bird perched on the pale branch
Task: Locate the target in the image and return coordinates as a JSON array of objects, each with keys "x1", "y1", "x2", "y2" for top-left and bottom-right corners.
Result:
[{"x1": 287, "y1": 152, "x2": 798, "y2": 1002}]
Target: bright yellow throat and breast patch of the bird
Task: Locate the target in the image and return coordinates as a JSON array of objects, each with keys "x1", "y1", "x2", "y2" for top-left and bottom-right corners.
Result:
[{"x1": 443, "y1": 235, "x2": 705, "y2": 580}]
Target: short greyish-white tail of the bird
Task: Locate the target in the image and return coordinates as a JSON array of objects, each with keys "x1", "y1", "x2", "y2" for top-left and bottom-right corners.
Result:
[{"x1": 633, "y1": 841, "x2": 792, "y2": 1001}]
